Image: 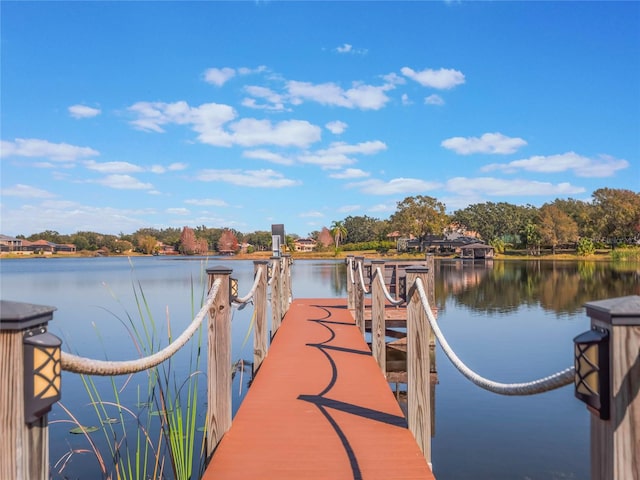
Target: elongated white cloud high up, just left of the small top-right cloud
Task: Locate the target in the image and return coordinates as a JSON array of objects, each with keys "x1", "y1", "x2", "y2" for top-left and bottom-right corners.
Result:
[{"x1": 287, "y1": 81, "x2": 395, "y2": 110}]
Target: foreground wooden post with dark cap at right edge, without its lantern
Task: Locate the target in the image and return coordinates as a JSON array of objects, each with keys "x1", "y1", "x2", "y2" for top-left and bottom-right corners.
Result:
[{"x1": 585, "y1": 295, "x2": 640, "y2": 480}]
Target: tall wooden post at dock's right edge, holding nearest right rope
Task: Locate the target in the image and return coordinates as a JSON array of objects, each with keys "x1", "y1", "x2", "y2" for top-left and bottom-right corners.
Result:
[{"x1": 406, "y1": 267, "x2": 431, "y2": 464}]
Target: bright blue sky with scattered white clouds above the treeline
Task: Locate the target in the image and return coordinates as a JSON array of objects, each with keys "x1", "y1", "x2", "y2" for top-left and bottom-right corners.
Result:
[{"x1": 0, "y1": 1, "x2": 640, "y2": 236}]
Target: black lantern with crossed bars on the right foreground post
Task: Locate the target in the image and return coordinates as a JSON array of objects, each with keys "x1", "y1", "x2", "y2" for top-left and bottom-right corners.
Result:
[{"x1": 573, "y1": 326, "x2": 610, "y2": 420}]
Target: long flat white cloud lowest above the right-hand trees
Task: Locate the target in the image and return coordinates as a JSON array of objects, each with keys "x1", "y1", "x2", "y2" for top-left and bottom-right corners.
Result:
[{"x1": 446, "y1": 177, "x2": 585, "y2": 196}]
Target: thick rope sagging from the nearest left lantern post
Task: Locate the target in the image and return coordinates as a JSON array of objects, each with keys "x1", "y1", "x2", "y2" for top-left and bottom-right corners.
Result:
[{"x1": 61, "y1": 278, "x2": 222, "y2": 376}]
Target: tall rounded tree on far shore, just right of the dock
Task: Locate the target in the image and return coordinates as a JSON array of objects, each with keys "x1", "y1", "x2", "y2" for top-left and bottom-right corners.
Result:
[{"x1": 389, "y1": 195, "x2": 449, "y2": 240}]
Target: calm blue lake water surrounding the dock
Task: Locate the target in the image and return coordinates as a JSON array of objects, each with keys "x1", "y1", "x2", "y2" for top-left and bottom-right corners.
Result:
[{"x1": 0, "y1": 257, "x2": 640, "y2": 480}]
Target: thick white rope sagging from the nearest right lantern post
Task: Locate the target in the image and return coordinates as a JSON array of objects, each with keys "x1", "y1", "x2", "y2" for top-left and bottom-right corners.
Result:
[{"x1": 415, "y1": 278, "x2": 575, "y2": 395}]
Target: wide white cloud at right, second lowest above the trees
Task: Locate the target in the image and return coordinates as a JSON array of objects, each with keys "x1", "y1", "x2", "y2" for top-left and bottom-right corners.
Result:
[{"x1": 482, "y1": 152, "x2": 629, "y2": 178}]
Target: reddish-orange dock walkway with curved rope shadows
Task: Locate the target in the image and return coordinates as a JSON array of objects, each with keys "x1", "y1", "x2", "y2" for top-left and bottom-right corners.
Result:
[{"x1": 203, "y1": 299, "x2": 434, "y2": 480}]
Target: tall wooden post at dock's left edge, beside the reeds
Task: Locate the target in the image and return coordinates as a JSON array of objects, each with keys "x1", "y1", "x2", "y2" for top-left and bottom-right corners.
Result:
[{"x1": 207, "y1": 266, "x2": 232, "y2": 457}]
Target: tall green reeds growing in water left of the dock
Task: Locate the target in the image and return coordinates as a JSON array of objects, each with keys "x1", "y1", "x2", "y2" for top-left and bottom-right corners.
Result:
[{"x1": 56, "y1": 262, "x2": 210, "y2": 480}]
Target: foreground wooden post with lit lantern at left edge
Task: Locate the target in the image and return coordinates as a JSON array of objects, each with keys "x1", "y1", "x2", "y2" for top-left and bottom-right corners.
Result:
[{"x1": 0, "y1": 300, "x2": 62, "y2": 480}]
